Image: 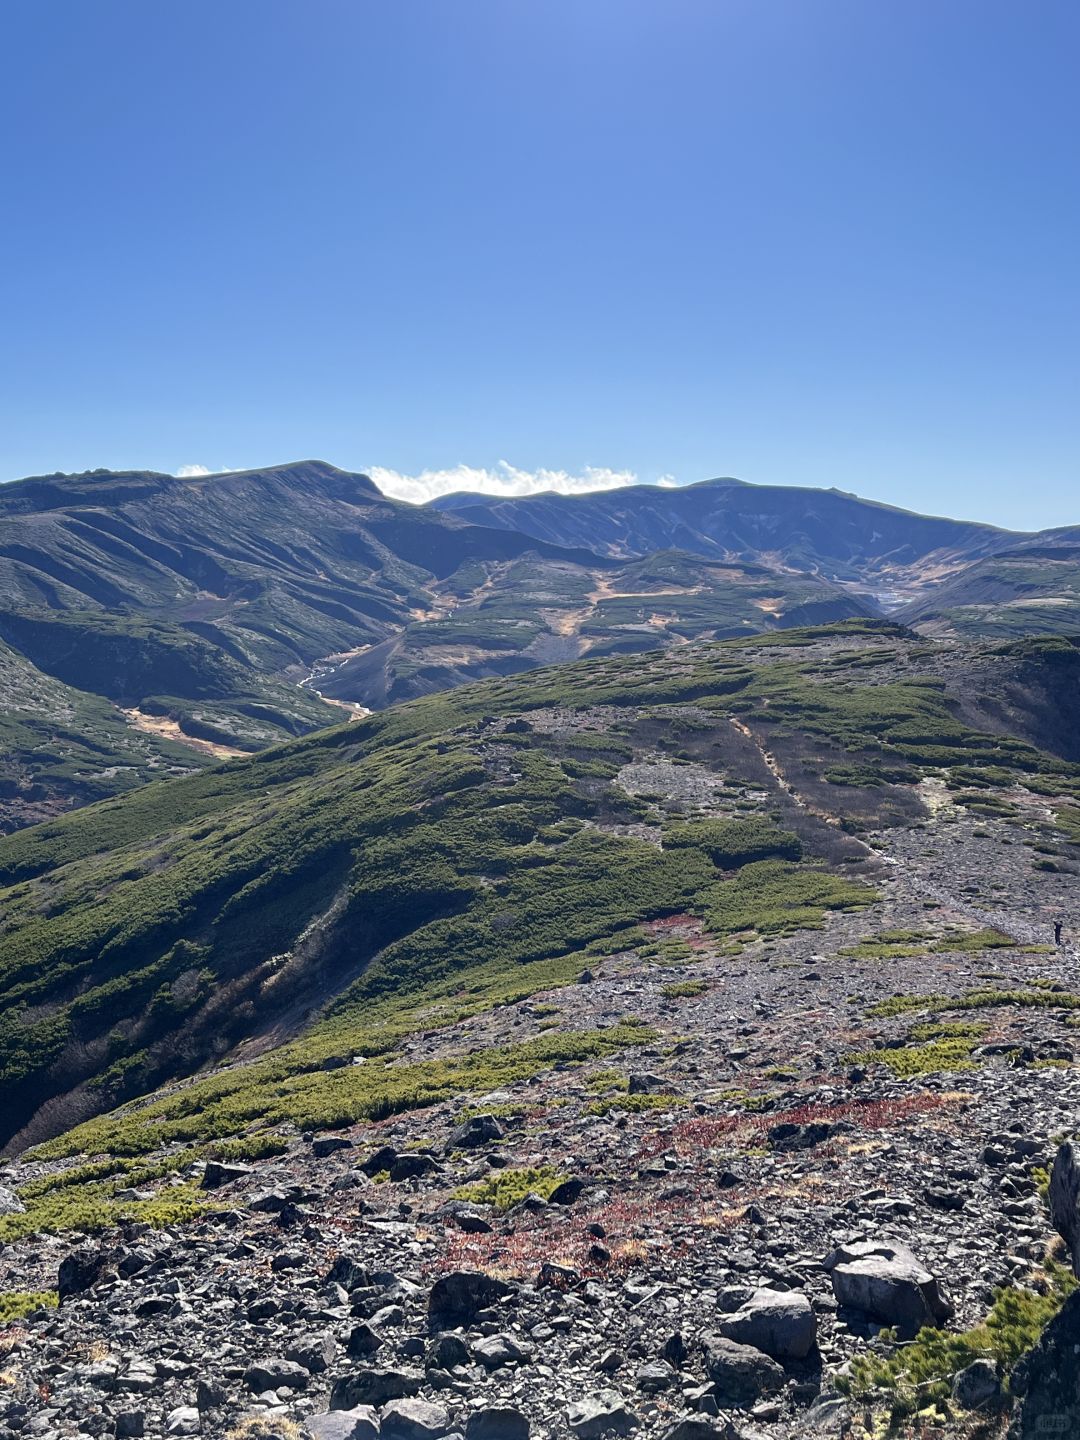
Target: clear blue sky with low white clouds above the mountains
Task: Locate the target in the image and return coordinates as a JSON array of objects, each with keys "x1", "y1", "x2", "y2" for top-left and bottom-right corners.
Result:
[{"x1": 0, "y1": 0, "x2": 1080, "y2": 527}]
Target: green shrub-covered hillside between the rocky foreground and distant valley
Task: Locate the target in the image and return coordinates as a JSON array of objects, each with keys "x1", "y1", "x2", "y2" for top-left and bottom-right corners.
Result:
[{"x1": 0, "y1": 624, "x2": 1080, "y2": 1149}]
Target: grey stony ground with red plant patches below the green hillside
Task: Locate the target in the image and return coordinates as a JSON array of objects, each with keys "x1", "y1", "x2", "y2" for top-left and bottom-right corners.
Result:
[{"x1": 0, "y1": 765, "x2": 1080, "y2": 1440}]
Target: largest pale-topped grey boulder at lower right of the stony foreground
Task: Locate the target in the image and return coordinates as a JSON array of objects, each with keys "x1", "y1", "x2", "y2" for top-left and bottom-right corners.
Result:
[{"x1": 824, "y1": 1240, "x2": 953, "y2": 1339}]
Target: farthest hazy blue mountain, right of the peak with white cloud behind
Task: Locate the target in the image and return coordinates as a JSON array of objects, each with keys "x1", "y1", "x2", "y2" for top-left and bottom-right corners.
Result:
[{"x1": 432, "y1": 480, "x2": 1018, "y2": 603}]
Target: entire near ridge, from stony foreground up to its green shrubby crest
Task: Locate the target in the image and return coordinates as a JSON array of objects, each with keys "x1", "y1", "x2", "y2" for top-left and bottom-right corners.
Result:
[{"x1": 0, "y1": 622, "x2": 1080, "y2": 1440}]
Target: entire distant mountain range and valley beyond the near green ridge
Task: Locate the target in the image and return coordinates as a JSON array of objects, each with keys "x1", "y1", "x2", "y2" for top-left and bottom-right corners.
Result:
[{"x1": 0, "y1": 461, "x2": 1080, "y2": 828}]
